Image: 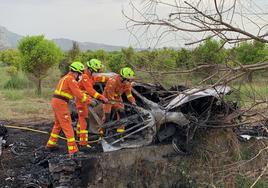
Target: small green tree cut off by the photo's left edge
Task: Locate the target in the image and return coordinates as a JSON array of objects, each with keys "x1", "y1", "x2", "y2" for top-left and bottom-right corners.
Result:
[{"x1": 0, "y1": 49, "x2": 21, "y2": 69}]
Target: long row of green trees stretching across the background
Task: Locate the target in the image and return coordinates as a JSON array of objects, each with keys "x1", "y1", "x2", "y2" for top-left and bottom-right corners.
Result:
[{"x1": 0, "y1": 36, "x2": 268, "y2": 94}]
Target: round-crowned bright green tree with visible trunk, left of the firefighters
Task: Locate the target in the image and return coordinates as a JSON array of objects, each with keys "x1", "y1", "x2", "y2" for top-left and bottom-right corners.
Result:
[{"x1": 18, "y1": 35, "x2": 62, "y2": 95}]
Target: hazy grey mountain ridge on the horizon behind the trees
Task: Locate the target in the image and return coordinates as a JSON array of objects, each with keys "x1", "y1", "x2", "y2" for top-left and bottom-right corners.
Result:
[{"x1": 0, "y1": 26, "x2": 124, "y2": 51}]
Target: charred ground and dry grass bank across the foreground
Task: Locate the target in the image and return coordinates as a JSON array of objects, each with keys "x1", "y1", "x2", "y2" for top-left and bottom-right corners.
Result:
[{"x1": 0, "y1": 121, "x2": 268, "y2": 188}]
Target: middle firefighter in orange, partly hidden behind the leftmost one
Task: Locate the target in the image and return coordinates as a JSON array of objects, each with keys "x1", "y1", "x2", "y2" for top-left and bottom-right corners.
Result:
[{"x1": 76, "y1": 59, "x2": 109, "y2": 148}]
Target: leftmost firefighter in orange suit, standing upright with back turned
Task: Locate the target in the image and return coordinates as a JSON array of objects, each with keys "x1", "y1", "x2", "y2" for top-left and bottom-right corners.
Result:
[{"x1": 46, "y1": 62, "x2": 91, "y2": 156}]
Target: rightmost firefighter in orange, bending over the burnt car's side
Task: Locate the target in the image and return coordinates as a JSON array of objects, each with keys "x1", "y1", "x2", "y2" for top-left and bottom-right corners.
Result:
[{"x1": 102, "y1": 67, "x2": 136, "y2": 134}]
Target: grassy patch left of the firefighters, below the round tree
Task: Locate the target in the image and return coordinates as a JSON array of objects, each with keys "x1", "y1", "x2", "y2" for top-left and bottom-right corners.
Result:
[{"x1": 0, "y1": 62, "x2": 60, "y2": 120}]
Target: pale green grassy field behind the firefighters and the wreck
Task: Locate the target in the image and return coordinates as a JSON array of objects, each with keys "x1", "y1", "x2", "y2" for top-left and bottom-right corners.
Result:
[{"x1": 0, "y1": 63, "x2": 268, "y2": 120}]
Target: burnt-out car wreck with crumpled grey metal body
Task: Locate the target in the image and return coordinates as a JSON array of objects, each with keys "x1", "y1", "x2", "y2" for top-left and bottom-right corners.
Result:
[{"x1": 72, "y1": 72, "x2": 237, "y2": 154}]
